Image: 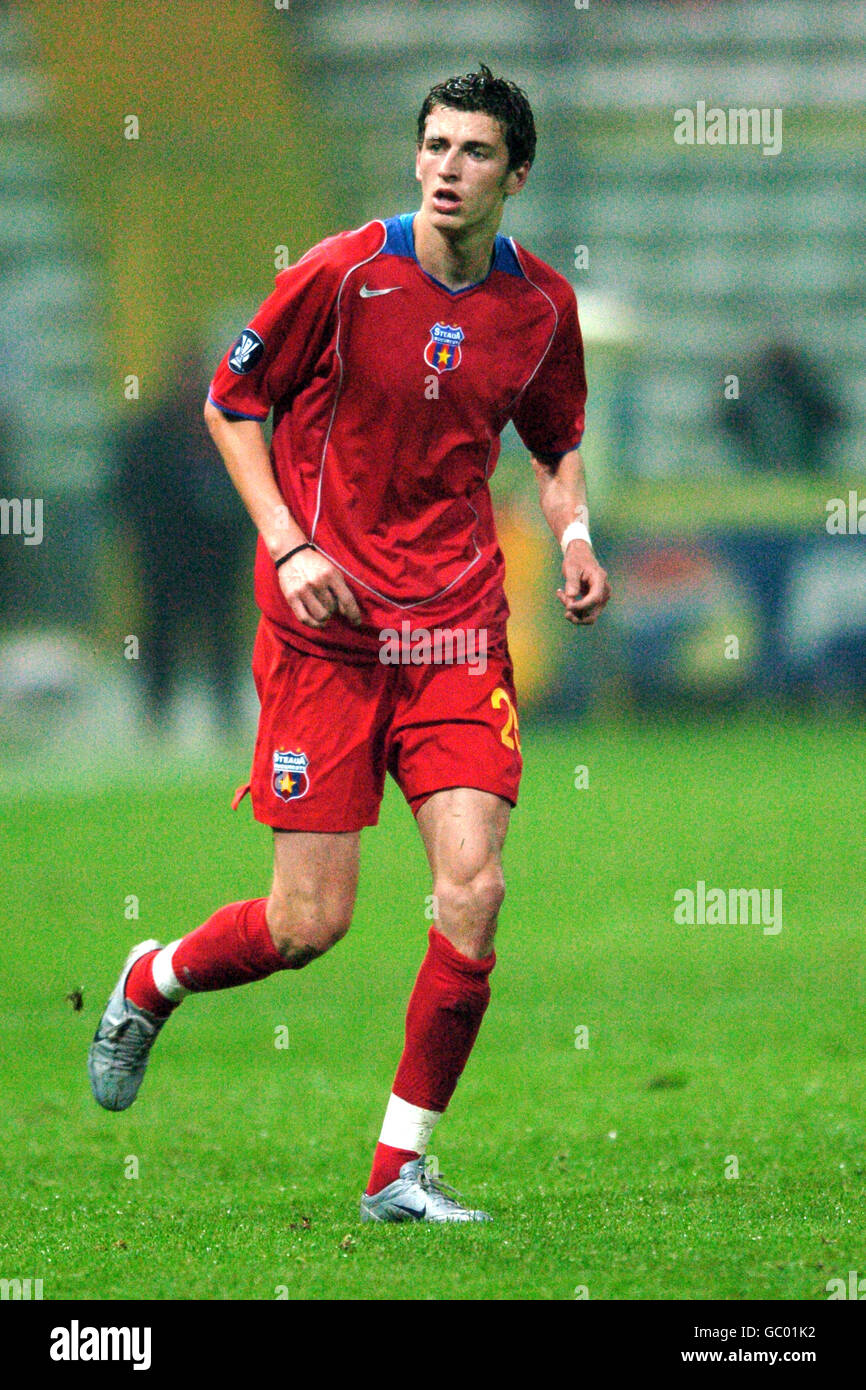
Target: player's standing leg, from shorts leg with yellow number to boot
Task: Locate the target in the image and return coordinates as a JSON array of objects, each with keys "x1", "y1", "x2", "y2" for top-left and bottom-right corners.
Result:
[{"x1": 361, "y1": 645, "x2": 523, "y2": 1220}]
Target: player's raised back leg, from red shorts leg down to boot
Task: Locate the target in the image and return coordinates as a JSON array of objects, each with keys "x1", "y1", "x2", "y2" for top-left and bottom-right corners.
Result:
[{"x1": 89, "y1": 619, "x2": 385, "y2": 1109}]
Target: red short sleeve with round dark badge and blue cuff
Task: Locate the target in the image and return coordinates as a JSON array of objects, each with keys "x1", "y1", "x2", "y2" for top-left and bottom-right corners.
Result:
[{"x1": 209, "y1": 243, "x2": 339, "y2": 421}]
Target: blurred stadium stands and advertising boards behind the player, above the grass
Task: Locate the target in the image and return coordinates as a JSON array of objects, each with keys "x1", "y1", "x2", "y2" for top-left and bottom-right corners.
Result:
[{"x1": 0, "y1": 0, "x2": 866, "y2": 770}]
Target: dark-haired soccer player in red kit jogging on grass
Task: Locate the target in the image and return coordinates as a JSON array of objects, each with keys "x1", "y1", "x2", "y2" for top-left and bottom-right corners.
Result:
[{"x1": 89, "y1": 65, "x2": 609, "y2": 1222}]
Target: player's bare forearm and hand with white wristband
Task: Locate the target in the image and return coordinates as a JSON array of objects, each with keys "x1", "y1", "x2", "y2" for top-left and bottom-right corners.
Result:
[{"x1": 532, "y1": 449, "x2": 610, "y2": 626}]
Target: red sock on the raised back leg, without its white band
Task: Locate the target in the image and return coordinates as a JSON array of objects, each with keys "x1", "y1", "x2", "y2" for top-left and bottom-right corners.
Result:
[{"x1": 126, "y1": 898, "x2": 289, "y2": 1015}]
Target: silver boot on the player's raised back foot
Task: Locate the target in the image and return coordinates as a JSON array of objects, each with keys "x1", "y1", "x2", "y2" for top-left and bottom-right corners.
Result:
[{"x1": 88, "y1": 941, "x2": 165, "y2": 1111}]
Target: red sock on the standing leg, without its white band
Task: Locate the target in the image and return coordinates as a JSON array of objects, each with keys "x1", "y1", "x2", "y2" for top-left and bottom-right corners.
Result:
[{"x1": 367, "y1": 927, "x2": 496, "y2": 1195}]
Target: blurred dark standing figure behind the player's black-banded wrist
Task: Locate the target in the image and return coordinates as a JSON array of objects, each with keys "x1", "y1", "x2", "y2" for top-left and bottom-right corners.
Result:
[{"x1": 114, "y1": 345, "x2": 253, "y2": 731}]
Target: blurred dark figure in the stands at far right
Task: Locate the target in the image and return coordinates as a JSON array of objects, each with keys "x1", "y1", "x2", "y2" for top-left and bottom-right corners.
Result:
[{"x1": 720, "y1": 342, "x2": 844, "y2": 473}]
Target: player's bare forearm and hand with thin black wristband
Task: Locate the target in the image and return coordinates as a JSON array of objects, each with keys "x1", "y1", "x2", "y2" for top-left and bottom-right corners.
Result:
[{"x1": 204, "y1": 400, "x2": 361, "y2": 627}]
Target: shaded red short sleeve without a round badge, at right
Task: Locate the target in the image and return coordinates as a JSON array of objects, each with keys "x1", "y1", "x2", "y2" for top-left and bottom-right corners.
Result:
[{"x1": 512, "y1": 291, "x2": 587, "y2": 455}]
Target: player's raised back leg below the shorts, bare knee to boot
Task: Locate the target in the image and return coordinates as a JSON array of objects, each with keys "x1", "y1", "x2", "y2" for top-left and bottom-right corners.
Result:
[{"x1": 88, "y1": 831, "x2": 360, "y2": 1111}]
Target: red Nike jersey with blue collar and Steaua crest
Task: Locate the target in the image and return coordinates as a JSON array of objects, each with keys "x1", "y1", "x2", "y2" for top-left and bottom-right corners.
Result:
[{"x1": 210, "y1": 213, "x2": 587, "y2": 662}]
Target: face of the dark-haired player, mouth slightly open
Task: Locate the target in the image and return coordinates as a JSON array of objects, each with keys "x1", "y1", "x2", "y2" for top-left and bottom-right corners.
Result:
[{"x1": 416, "y1": 106, "x2": 530, "y2": 232}]
